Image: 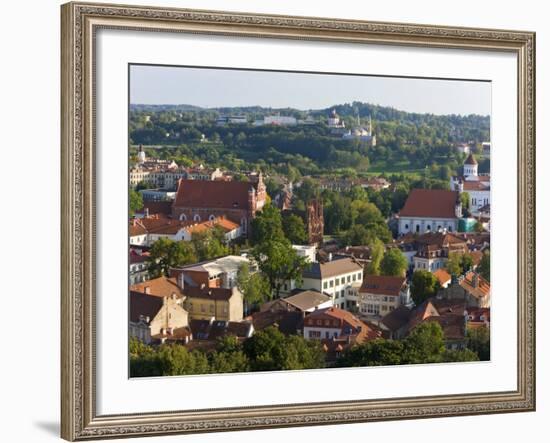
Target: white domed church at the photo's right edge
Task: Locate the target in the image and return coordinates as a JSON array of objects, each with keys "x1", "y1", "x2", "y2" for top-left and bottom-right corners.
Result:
[{"x1": 451, "y1": 154, "x2": 491, "y2": 214}]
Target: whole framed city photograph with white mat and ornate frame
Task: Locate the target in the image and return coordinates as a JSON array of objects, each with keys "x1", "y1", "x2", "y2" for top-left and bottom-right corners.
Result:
[{"x1": 61, "y1": 2, "x2": 535, "y2": 441}]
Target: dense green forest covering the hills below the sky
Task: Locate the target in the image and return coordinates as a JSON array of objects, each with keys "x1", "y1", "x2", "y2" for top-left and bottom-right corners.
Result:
[{"x1": 130, "y1": 102, "x2": 490, "y2": 178}]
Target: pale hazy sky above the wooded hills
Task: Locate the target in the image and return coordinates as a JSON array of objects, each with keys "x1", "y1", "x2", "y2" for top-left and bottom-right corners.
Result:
[{"x1": 130, "y1": 65, "x2": 491, "y2": 115}]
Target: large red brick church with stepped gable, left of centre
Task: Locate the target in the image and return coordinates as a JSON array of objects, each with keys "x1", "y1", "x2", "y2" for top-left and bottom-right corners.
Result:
[{"x1": 172, "y1": 173, "x2": 267, "y2": 235}]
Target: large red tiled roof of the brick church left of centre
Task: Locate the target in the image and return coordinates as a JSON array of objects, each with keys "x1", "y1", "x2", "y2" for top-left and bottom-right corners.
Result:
[{"x1": 174, "y1": 179, "x2": 255, "y2": 209}]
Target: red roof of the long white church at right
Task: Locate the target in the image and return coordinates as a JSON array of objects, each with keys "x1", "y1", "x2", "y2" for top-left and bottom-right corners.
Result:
[{"x1": 399, "y1": 189, "x2": 458, "y2": 218}]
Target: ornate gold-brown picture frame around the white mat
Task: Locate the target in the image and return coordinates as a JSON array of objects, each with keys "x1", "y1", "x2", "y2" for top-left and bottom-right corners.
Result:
[{"x1": 61, "y1": 3, "x2": 535, "y2": 441}]
